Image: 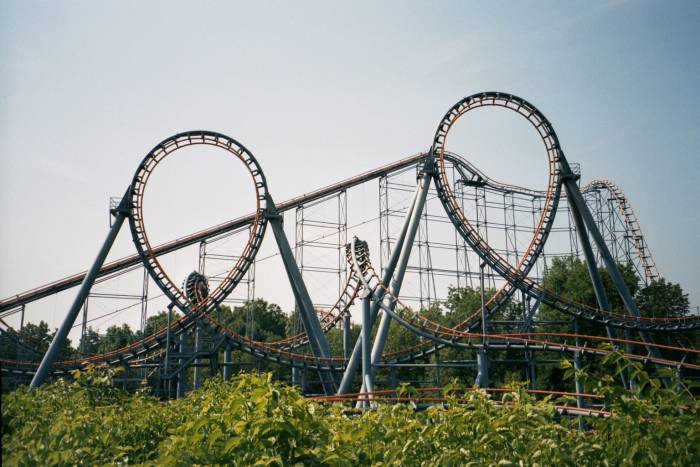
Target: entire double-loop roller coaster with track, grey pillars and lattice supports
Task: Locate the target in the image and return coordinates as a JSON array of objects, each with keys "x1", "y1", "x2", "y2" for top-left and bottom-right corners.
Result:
[{"x1": 0, "y1": 92, "x2": 700, "y2": 410}]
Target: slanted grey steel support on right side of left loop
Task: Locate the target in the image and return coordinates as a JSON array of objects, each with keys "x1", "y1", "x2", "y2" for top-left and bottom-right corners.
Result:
[{"x1": 266, "y1": 195, "x2": 337, "y2": 395}]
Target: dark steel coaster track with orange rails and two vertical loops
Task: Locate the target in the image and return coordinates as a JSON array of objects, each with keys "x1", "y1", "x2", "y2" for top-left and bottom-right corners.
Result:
[{"x1": 0, "y1": 92, "x2": 700, "y2": 395}]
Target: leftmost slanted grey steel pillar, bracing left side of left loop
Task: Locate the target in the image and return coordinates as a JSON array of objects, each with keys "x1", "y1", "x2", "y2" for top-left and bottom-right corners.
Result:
[{"x1": 29, "y1": 199, "x2": 129, "y2": 388}]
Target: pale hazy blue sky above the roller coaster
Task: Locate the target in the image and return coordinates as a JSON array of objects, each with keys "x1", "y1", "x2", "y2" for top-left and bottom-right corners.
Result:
[{"x1": 0, "y1": 0, "x2": 700, "y2": 336}]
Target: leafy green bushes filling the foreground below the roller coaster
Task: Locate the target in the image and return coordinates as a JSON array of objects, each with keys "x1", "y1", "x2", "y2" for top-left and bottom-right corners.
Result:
[{"x1": 2, "y1": 352, "x2": 700, "y2": 466}]
